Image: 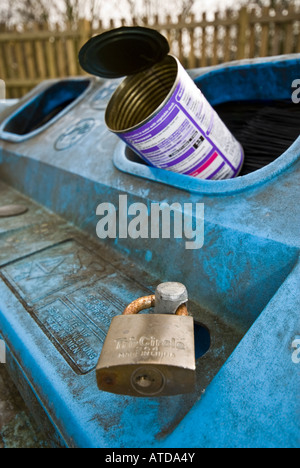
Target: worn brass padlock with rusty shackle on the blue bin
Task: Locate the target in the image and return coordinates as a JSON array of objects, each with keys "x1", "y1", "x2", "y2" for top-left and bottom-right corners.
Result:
[{"x1": 96, "y1": 283, "x2": 196, "y2": 397}]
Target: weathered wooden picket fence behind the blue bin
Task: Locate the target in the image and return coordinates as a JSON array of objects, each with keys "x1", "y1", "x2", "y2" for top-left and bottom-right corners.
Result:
[{"x1": 0, "y1": 7, "x2": 300, "y2": 98}]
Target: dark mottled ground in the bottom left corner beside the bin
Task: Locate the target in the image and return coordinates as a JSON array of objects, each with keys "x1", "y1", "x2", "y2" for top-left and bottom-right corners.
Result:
[{"x1": 0, "y1": 364, "x2": 49, "y2": 448}]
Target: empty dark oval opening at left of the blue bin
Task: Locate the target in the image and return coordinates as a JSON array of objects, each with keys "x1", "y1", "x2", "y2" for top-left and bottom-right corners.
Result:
[{"x1": 3, "y1": 80, "x2": 90, "y2": 135}]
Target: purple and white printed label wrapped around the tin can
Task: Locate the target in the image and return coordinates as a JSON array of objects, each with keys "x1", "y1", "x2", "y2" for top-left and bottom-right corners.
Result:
[{"x1": 119, "y1": 62, "x2": 244, "y2": 180}]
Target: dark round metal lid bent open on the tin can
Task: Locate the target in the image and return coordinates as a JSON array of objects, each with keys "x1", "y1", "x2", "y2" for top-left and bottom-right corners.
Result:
[{"x1": 79, "y1": 26, "x2": 170, "y2": 78}]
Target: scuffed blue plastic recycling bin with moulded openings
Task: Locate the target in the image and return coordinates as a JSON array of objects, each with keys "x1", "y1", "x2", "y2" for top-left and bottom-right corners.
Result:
[{"x1": 0, "y1": 55, "x2": 300, "y2": 449}]
